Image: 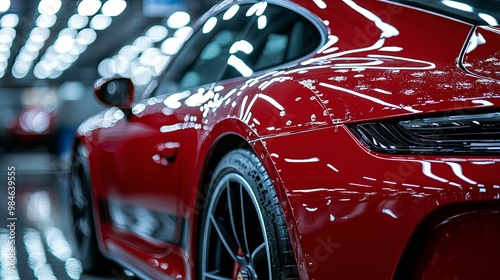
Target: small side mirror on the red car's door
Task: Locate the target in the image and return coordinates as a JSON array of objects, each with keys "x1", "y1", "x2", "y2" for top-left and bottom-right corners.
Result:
[{"x1": 94, "y1": 78, "x2": 135, "y2": 110}]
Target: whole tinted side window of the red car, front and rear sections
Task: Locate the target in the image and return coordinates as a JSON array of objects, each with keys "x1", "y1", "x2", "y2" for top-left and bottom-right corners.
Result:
[{"x1": 156, "y1": 2, "x2": 321, "y2": 95}]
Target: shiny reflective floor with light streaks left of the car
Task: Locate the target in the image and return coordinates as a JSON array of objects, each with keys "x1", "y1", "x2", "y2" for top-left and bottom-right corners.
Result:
[{"x1": 0, "y1": 151, "x2": 132, "y2": 280}]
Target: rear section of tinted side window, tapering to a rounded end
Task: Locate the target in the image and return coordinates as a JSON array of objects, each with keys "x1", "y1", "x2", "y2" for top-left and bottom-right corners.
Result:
[{"x1": 224, "y1": 2, "x2": 321, "y2": 78}]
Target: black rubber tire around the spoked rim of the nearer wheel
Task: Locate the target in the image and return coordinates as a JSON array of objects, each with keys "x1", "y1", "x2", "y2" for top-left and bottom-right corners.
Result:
[{"x1": 198, "y1": 149, "x2": 299, "y2": 279}]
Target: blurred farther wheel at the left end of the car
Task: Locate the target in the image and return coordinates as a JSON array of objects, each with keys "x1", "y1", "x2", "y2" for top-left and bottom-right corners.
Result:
[{"x1": 69, "y1": 146, "x2": 110, "y2": 273}]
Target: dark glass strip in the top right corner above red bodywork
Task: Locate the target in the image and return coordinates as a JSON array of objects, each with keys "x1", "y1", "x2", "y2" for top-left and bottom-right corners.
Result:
[{"x1": 395, "y1": 0, "x2": 500, "y2": 26}]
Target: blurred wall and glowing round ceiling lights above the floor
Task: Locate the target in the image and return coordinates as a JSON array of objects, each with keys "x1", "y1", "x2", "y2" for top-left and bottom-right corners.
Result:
[{"x1": 0, "y1": 0, "x2": 216, "y2": 162}]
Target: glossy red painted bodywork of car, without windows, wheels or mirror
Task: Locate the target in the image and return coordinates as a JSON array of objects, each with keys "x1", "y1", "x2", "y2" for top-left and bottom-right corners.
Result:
[{"x1": 72, "y1": 0, "x2": 500, "y2": 279}]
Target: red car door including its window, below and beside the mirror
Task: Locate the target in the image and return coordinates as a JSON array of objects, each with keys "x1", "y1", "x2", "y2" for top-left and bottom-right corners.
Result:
[{"x1": 100, "y1": 4, "x2": 260, "y2": 249}]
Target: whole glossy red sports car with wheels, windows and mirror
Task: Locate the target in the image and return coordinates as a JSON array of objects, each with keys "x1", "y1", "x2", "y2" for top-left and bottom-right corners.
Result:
[{"x1": 70, "y1": 0, "x2": 500, "y2": 280}]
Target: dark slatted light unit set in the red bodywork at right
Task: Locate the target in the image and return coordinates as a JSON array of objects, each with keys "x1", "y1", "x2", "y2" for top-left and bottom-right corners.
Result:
[{"x1": 350, "y1": 112, "x2": 500, "y2": 155}]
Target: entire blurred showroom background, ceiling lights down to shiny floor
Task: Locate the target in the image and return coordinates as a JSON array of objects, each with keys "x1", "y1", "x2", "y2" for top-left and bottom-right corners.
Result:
[{"x1": 0, "y1": 0, "x2": 217, "y2": 280}]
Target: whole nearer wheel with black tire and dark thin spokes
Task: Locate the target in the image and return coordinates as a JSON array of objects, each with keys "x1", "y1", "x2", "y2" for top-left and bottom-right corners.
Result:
[{"x1": 199, "y1": 150, "x2": 298, "y2": 279}]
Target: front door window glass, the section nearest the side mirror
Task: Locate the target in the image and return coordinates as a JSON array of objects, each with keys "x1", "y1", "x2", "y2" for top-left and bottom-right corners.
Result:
[{"x1": 155, "y1": 4, "x2": 252, "y2": 95}]
